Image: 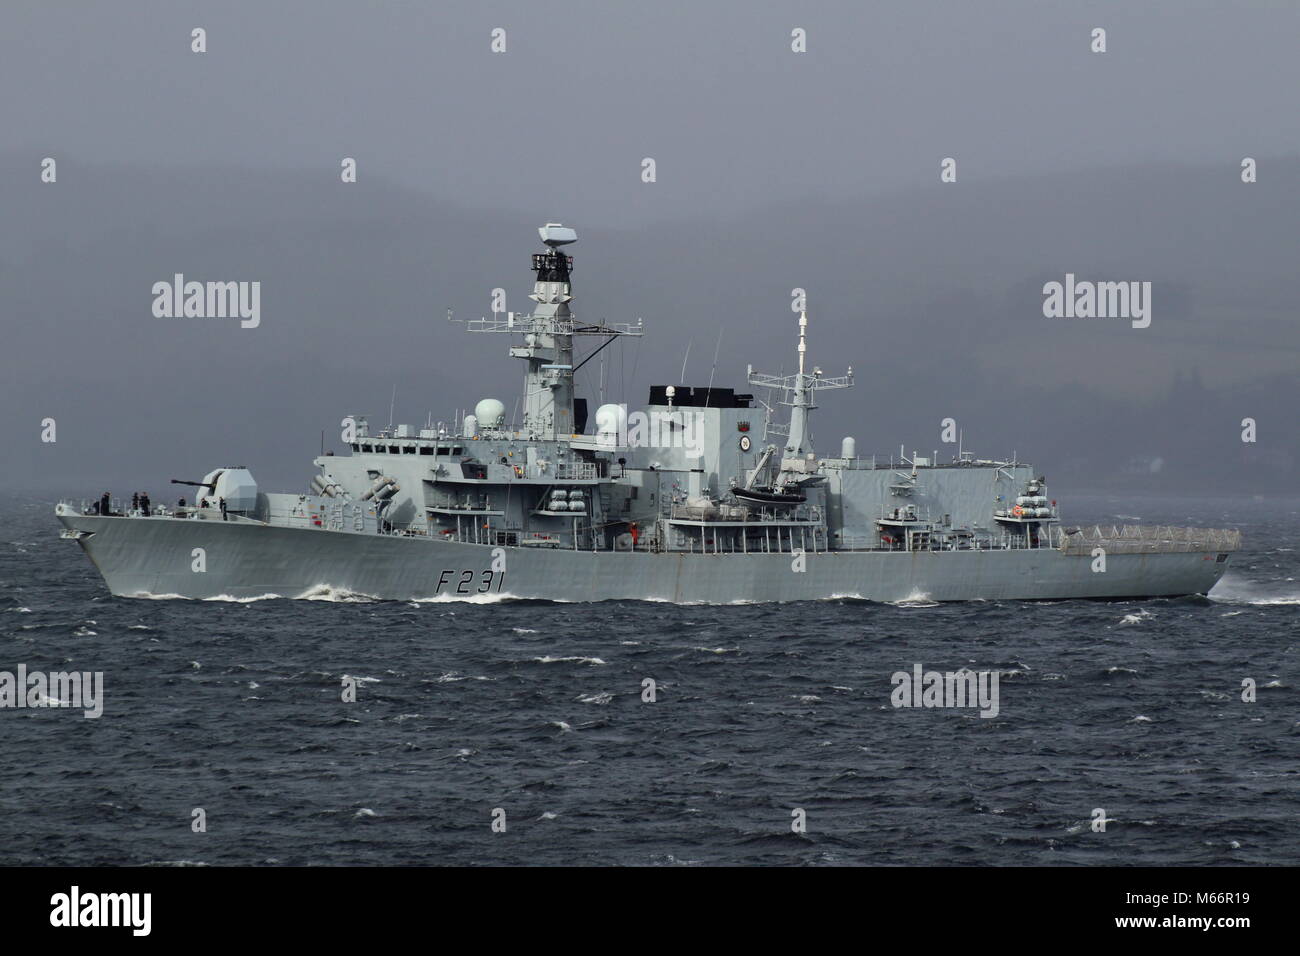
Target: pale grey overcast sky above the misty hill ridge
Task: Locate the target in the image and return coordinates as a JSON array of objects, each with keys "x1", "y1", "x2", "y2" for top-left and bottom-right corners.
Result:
[{"x1": 10, "y1": 0, "x2": 1300, "y2": 214}]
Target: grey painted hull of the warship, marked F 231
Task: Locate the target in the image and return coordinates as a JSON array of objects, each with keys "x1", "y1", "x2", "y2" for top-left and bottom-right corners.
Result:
[{"x1": 59, "y1": 514, "x2": 1227, "y2": 604}]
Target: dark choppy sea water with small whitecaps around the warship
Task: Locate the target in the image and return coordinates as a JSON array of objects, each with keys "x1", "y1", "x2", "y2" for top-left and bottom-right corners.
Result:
[{"x1": 0, "y1": 498, "x2": 1300, "y2": 865}]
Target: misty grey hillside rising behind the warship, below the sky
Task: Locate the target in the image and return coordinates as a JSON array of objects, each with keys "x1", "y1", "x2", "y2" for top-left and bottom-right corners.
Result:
[{"x1": 0, "y1": 153, "x2": 1300, "y2": 494}]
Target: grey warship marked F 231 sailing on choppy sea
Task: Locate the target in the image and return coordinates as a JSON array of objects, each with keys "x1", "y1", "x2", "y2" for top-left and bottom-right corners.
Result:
[{"x1": 56, "y1": 222, "x2": 1240, "y2": 604}]
